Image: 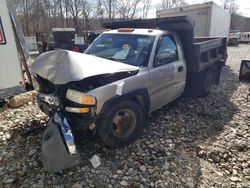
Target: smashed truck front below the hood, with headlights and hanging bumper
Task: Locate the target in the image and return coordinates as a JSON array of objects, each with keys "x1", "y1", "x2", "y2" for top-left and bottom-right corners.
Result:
[{"x1": 36, "y1": 75, "x2": 96, "y2": 172}]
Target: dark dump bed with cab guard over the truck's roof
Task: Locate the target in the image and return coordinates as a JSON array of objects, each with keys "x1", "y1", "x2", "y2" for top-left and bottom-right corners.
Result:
[{"x1": 103, "y1": 16, "x2": 227, "y2": 73}]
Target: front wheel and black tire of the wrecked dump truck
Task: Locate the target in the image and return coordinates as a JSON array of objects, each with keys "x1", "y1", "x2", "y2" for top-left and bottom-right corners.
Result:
[{"x1": 97, "y1": 101, "x2": 145, "y2": 147}]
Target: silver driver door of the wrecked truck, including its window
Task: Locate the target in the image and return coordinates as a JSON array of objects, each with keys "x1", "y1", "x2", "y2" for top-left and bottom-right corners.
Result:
[{"x1": 149, "y1": 35, "x2": 179, "y2": 110}]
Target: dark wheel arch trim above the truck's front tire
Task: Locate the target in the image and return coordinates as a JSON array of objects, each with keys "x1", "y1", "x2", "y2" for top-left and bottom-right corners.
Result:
[{"x1": 100, "y1": 88, "x2": 150, "y2": 118}]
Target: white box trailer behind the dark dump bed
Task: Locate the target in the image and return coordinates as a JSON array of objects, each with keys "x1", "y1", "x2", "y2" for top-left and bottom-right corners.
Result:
[{"x1": 156, "y1": 1, "x2": 231, "y2": 37}]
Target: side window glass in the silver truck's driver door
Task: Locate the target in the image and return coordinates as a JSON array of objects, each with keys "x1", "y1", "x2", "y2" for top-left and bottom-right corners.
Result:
[{"x1": 154, "y1": 35, "x2": 179, "y2": 67}]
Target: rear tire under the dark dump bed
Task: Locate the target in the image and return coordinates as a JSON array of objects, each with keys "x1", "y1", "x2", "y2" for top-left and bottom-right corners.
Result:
[{"x1": 199, "y1": 70, "x2": 213, "y2": 97}]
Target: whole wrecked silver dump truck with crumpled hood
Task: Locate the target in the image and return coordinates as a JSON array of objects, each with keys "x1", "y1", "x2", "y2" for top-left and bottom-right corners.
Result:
[{"x1": 32, "y1": 17, "x2": 227, "y2": 171}]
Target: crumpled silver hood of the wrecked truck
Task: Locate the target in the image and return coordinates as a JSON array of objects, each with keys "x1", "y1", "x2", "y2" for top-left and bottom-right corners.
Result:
[{"x1": 31, "y1": 50, "x2": 139, "y2": 84}]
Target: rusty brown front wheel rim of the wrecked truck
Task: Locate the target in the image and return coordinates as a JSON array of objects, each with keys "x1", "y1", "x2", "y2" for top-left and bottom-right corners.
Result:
[{"x1": 112, "y1": 109, "x2": 136, "y2": 137}]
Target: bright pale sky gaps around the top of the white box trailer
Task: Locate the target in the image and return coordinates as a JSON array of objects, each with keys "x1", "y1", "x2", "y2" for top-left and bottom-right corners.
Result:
[{"x1": 148, "y1": 0, "x2": 250, "y2": 18}]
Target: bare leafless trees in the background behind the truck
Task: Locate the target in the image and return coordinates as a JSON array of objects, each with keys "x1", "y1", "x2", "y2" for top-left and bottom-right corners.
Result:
[{"x1": 13, "y1": 0, "x2": 188, "y2": 36}]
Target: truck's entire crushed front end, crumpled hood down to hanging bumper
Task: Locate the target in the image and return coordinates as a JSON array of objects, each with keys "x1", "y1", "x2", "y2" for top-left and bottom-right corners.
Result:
[{"x1": 31, "y1": 50, "x2": 139, "y2": 172}]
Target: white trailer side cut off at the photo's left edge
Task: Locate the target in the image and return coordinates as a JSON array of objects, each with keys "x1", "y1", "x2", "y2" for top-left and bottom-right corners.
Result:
[{"x1": 0, "y1": 0, "x2": 32, "y2": 100}]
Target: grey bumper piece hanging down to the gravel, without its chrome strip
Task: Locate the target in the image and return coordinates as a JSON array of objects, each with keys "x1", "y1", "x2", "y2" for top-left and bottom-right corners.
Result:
[{"x1": 42, "y1": 112, "x2": 80, "y2": 173}]
